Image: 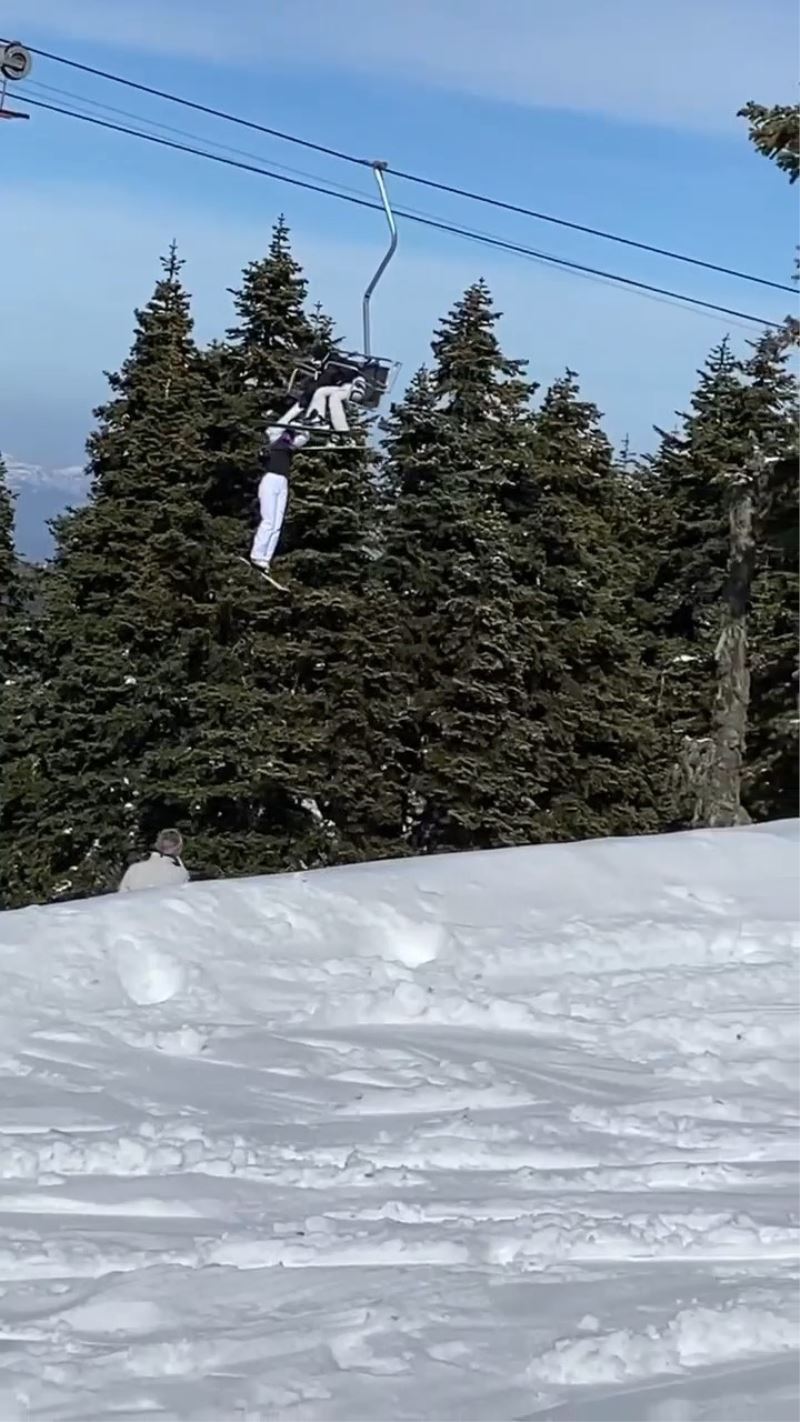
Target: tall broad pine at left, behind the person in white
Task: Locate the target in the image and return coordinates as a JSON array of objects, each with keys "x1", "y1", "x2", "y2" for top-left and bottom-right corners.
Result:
[{"x1": 0, "y1": 249, "x2": 250, "y2": 900}]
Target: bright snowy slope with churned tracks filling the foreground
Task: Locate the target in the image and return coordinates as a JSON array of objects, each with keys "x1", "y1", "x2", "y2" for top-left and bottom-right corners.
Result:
[{"x1": 0, "y1": 823, "x2": 799, "y2": 1422}]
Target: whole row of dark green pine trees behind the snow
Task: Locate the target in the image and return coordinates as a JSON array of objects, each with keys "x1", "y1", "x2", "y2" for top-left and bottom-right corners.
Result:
[{"x1": 0, "y1": 103, "x2": 797, "y2": 907}]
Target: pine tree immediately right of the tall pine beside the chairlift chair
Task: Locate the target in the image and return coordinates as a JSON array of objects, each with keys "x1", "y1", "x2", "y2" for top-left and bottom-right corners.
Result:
[{"x1": 516, "y1": 370, "x2": 664, "y2": 840}]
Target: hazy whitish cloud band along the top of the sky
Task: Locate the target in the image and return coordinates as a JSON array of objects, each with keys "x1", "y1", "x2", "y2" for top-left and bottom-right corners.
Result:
[{"x1": 3, "y1": 0, "x2": 799, "y2": 132}]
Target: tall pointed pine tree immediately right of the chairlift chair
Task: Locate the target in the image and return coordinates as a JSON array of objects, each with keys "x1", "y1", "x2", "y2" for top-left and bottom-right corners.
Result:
[{"x1": 381, "y1": 282, "x2": 537, "y2": 852}]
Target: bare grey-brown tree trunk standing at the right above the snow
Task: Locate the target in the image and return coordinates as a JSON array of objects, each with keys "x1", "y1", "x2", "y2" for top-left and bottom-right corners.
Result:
[{"x1": 685, "y1": 464, "x2": 757, "y2": 828}]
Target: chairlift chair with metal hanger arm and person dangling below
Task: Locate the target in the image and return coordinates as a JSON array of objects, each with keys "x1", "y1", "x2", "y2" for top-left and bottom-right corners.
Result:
[{"x1": 243, "y1": 162, "x2": 398, "y2": 587}]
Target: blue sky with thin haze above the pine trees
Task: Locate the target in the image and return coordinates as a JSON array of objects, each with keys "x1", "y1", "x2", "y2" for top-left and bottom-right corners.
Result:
[{"x1": 0, "y1": 0, "x2": 797, "y2": 548}]
